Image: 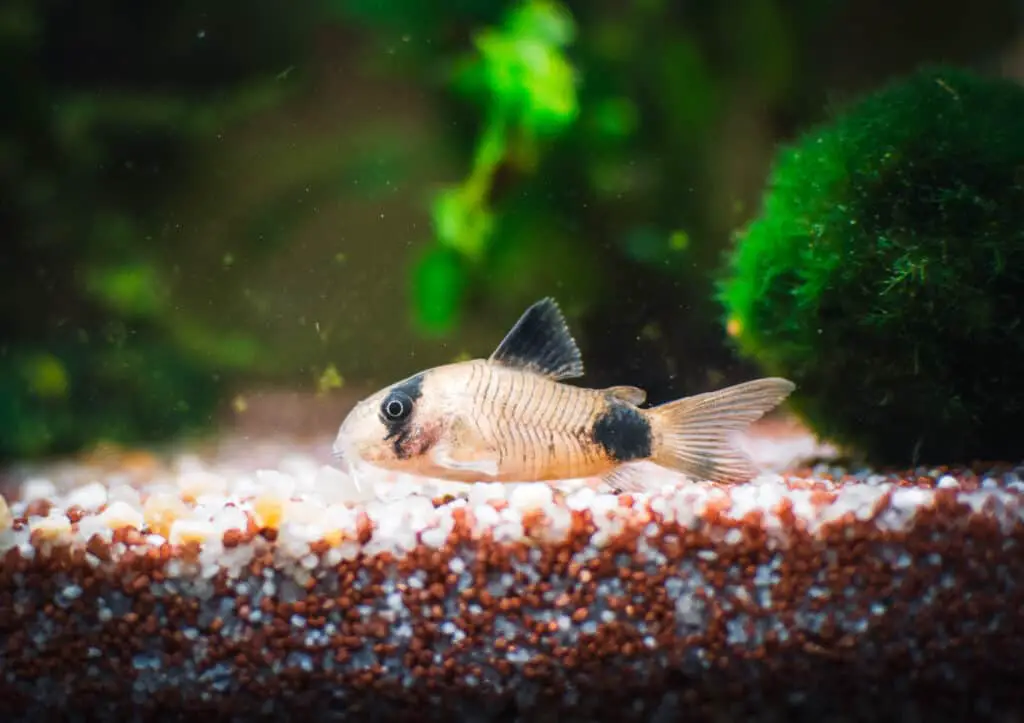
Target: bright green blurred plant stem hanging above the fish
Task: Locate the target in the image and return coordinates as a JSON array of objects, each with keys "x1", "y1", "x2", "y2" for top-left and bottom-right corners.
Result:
[{"x1": 413, "y1": 0, "x2": 579, "y2": 332}]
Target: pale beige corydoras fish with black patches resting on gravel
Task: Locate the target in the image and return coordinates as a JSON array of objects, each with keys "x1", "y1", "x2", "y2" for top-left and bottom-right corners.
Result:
[{"x1": 332, "y1": 296, "x2": 796, "y2": 493}]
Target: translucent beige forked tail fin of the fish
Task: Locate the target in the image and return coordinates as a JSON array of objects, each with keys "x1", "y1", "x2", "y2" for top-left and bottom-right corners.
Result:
[{"x1": 647, "y1": 377, "x2": 797, "y2": 482}]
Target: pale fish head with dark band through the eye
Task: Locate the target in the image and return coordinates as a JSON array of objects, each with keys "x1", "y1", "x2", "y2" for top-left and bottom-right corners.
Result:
[{"x1": 334, "y1": 370, "x2": 458, "y2": 473}]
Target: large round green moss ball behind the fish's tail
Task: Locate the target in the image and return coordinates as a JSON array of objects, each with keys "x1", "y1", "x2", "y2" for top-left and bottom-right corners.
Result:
[{"x1": 720, "y1": 68, "x2": 1024, "y2": 465}]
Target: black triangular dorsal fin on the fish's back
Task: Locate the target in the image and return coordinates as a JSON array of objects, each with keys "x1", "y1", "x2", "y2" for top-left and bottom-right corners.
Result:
[{"x1": 488, "y1": 297, "x2": 583, "y2": 380}]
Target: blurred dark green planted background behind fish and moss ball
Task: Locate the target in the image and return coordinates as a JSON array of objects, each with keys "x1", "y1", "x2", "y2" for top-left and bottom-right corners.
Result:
[{"x1": 0, "y1": 0, "x2": 1024, "y2": 459}]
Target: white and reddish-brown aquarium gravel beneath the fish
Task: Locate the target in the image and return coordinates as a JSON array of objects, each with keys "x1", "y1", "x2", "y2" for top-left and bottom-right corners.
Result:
[{"x1": 0, "y1": 426, "x2": 1024, "y2": 722}]
